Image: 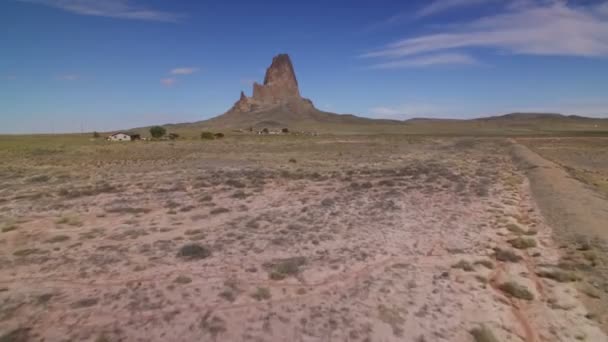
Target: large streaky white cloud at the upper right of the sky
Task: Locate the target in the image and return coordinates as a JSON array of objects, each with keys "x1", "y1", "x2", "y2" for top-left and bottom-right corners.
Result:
[{"x1": 363, "y1": 2, "x2": 608, "y2": 58}]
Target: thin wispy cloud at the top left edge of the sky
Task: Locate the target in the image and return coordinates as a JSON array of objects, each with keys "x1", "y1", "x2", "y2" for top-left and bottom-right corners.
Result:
[{"x1": 18, "y1": 0, "x2": 181, "y2": 22}]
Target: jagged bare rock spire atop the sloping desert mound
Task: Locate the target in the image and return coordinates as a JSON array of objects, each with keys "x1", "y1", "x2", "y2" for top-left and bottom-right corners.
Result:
[{"x1": 230, "y1": 54, "x2": 314, "y2": 113}]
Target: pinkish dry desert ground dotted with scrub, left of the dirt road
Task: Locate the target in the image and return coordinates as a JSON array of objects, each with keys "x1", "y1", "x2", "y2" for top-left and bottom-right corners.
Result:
[{"x1": 0, "y1": 138, "x2": 606, "y2": 342}]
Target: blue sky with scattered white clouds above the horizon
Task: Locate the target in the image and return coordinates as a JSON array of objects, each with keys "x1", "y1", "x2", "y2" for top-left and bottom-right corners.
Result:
[{"x1": 0, "y1": 0, "x2": 608, "y2": 133}]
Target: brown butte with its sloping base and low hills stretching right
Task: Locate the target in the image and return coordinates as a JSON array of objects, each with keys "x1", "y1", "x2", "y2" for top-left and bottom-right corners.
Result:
[{"x1": 128, "y1": 54, "x2": 608, "y2": 136}]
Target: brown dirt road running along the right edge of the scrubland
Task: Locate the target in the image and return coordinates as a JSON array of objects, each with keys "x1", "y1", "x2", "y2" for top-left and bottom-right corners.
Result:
[{"x1": 513, "y1": 144, "x2": 608, "y2": 331}]
